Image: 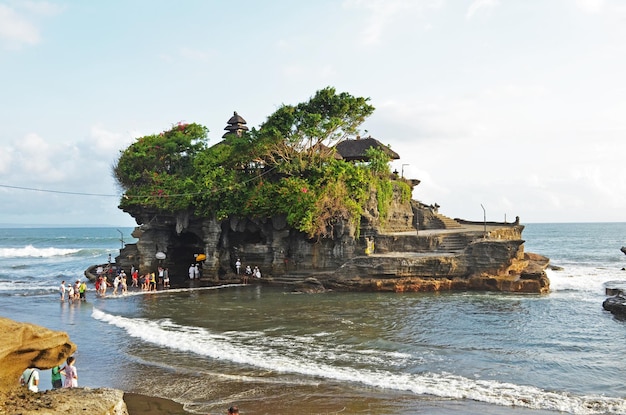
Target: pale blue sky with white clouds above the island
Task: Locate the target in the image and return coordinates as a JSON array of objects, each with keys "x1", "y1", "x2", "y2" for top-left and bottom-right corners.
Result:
[{"x1": 0, "y1": 0, "x2": 626, "y2": 226}]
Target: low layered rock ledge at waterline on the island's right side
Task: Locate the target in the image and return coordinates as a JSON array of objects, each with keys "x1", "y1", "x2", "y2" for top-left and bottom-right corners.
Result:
[{"x1": 325, "y1": 241, "x2": 550, "y2": 293}]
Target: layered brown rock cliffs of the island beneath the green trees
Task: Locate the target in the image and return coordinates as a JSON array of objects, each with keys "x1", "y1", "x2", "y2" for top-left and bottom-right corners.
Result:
[{"x1": 116, "y1": 186, "x2": 549, "y2": 293}]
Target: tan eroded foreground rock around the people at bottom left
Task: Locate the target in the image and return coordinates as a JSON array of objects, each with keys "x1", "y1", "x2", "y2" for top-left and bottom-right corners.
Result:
[{"x1": 0, "y1": 317, "x2": 128, "y2": 415}]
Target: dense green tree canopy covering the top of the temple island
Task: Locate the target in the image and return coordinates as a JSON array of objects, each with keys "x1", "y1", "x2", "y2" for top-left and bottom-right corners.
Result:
[{"x1": 113, "y1": 87, "x2": 408, "y2": 237}]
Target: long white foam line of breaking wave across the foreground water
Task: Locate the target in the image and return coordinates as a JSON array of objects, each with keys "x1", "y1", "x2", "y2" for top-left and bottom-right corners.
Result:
[{"x1": 92, "y1": 308, "x2": 626, "y2": 415}]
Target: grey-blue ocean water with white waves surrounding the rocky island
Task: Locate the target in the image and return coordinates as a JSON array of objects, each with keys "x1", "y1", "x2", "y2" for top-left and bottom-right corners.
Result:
[{"x1": 0, "y1": 223, "x2": 626, "y2": 415}]
